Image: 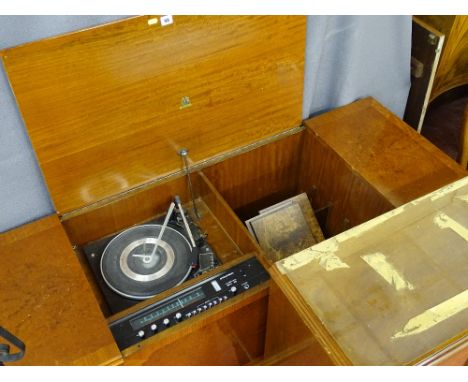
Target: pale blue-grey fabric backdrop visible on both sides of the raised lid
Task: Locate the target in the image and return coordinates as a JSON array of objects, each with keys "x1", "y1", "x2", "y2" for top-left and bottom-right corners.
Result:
[{"x1": 0, "y1": 16, "x2": 411, "y2": 232}]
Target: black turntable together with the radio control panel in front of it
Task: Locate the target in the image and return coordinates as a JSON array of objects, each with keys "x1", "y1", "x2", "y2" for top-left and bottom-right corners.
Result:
[{"x1": 82, "y1": 196, "x2": 269, "y2": 350}]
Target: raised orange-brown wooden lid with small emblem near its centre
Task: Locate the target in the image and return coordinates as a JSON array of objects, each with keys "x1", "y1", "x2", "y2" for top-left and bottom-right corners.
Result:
[{"x1": 2, "y1": 16, "x2": 306, "y2": 214}]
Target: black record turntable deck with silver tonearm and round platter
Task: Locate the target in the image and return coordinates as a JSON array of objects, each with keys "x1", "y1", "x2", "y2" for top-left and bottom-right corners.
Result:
[{"x1": 83, "y1": 196, "x2": 220, "y2": 313}]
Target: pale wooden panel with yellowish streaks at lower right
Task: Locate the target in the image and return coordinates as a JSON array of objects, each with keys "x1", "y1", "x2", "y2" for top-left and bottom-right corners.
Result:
[{"x1": 276, "y1": 177, "x2": 468, "y2": 365}]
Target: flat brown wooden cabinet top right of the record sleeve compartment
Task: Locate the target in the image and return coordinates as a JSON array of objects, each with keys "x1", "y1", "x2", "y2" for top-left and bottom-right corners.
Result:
[{"x1": 305, "y1": 98, "x2": 467, "y2": 207}]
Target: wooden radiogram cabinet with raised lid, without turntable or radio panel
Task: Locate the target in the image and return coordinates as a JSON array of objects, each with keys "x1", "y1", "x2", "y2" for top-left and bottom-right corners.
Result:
[{"x1": 0, "y1": 16, "x2": 466, "y2": 365}]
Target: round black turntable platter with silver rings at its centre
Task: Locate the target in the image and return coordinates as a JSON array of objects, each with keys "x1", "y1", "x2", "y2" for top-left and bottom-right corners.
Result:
[{"x1": 101, "y1": 224, "x2": 192, "y2": 300}]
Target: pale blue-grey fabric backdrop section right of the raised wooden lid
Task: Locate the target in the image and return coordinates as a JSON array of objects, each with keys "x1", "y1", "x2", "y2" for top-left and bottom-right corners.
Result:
[{"x1": 303, "y1": 16, "x2": 411, "y2": 118}]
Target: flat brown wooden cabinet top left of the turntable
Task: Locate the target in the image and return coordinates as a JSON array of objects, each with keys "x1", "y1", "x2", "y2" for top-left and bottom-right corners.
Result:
[{"x1": 0, "y1": 216, "x2": 121, "y2": 365}]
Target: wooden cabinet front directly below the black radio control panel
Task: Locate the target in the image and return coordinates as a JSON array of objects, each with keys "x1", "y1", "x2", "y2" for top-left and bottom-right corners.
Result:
[{"x1": 123, "y1": 283, "x2": 268, "y2": 366}]
